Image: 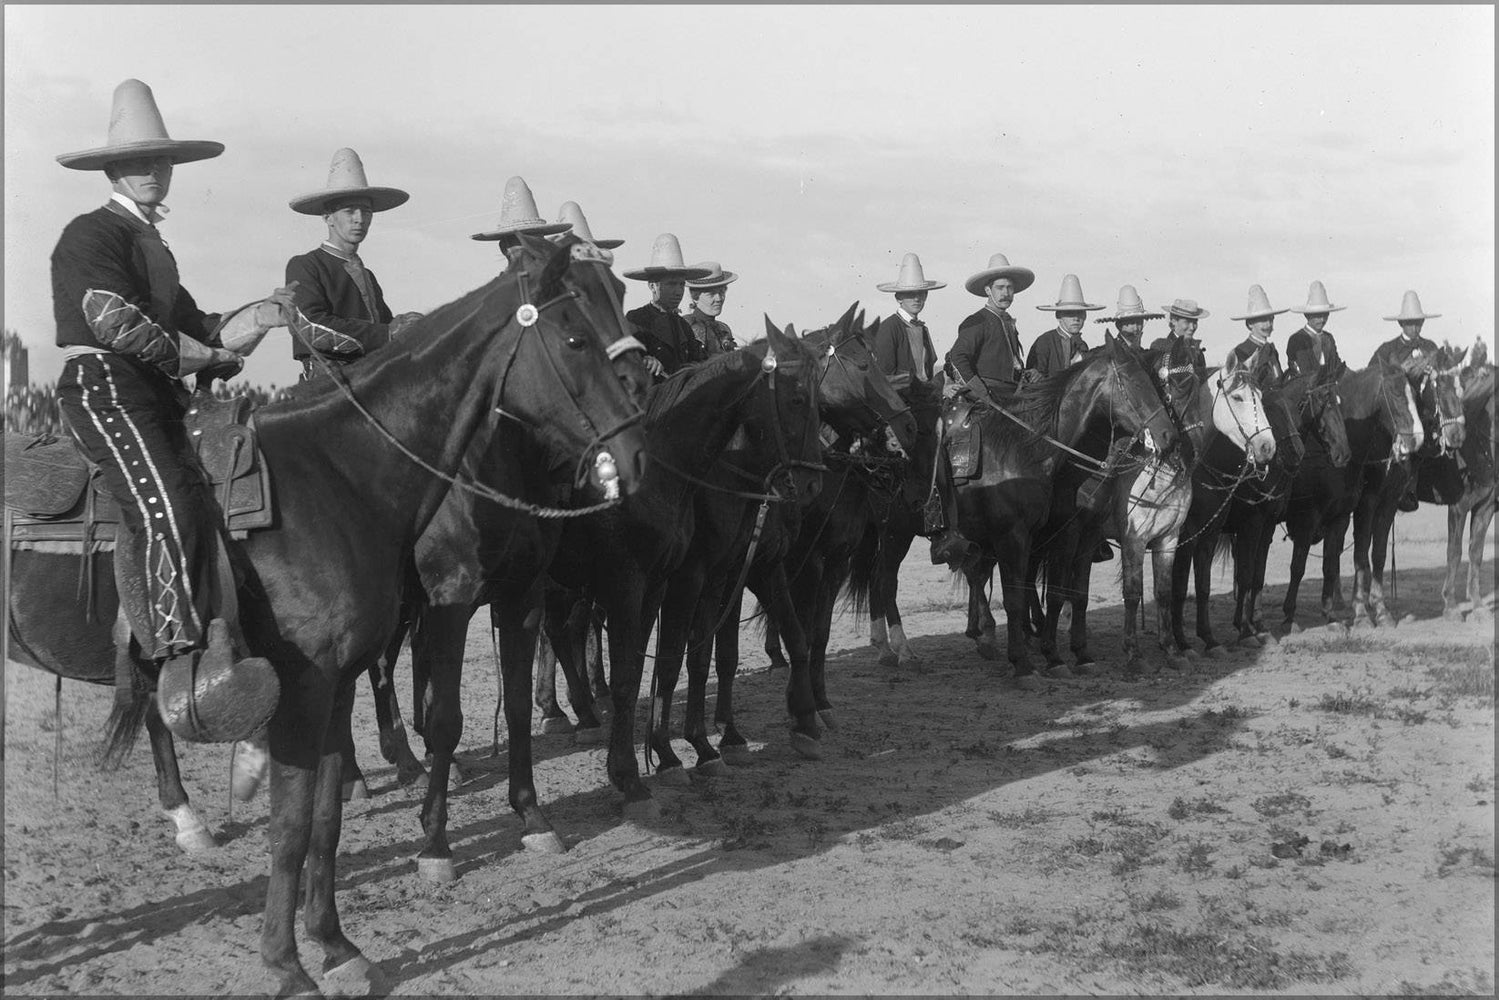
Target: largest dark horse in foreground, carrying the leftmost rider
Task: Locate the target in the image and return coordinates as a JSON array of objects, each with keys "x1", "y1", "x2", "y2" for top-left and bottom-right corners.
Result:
[{"x1": 10, "y1": 237, "x2": 645, "y2": 994}]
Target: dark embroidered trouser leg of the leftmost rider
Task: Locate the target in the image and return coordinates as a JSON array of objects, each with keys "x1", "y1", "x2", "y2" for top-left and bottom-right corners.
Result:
[{"x1": 57, "y1": 354, "x2": 219, "y2": 660}]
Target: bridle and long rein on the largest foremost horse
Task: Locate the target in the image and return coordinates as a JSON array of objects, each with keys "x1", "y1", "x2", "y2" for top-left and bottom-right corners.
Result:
[{"x1": 289, "y1": 263, "x2": 643, "y2": 520}]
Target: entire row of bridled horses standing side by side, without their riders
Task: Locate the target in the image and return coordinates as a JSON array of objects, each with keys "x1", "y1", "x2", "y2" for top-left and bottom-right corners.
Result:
[{"x1": 10, "y1": 237, "x2": 1493, "y2": 993}]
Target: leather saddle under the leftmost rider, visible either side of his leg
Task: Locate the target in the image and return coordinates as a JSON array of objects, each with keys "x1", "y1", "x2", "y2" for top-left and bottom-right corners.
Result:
[{"x1": 4, "y1": 396, "x2": 274, "y2": 550}]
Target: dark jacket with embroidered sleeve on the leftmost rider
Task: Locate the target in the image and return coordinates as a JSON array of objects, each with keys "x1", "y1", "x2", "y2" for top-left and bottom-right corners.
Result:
[{"x1": 52, "y1": 201, "x2": 219, "y2": 378}]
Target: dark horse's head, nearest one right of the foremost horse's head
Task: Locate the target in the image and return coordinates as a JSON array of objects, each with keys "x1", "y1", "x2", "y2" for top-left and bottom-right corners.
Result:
[{"x1": 742, "y1": 316, "x2": 826, "y2": 499}]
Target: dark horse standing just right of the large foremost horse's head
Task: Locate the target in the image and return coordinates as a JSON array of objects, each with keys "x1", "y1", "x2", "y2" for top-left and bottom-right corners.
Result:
[{"x1": 544, "y1": 325, "x2": 821, "y2": 819}]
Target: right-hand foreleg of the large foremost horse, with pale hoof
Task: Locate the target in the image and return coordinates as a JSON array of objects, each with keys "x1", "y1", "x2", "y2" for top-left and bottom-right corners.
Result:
[{"x1": 303, "y1": 679, "x2": 387, "y2": 996}]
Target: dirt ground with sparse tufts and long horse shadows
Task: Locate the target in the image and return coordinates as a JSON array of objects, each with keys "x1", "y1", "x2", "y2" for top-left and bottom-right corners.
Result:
[{"x1": 4, "y1": 508, "x2": 1495, "y2": 996}]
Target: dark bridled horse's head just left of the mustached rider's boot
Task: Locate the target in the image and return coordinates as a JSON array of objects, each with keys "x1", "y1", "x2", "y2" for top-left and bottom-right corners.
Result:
[{"x1": 802, "y1": 303, "x2": 916, "y2": 454}]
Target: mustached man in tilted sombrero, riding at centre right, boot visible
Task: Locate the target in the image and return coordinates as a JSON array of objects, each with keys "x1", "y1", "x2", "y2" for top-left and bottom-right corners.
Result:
[{"x1": 931, "y1": 253, "x2": 1036, "y2": 567}]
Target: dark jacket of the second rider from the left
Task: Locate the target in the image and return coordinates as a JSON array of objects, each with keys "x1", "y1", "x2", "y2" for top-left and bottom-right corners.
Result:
[{"x1": 286, "y1": 246, "x2": 391, "y2": 361}]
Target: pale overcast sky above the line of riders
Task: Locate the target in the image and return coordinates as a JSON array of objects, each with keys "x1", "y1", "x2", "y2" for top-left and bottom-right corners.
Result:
[{"x1": 4, "y1": 4, "x2": 1495, "y2": 384}]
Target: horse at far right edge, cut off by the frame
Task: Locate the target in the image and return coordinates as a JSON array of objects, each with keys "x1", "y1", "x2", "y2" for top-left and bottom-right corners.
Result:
[{"x1": 1442, "y1": 352, "x2": 1499, "y2": 624}]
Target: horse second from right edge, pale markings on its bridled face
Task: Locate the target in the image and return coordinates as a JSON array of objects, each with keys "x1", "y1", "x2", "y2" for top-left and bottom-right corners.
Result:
[{"x1": 1352, "y1": 345, "x2": 1466, "y2": 627}]
